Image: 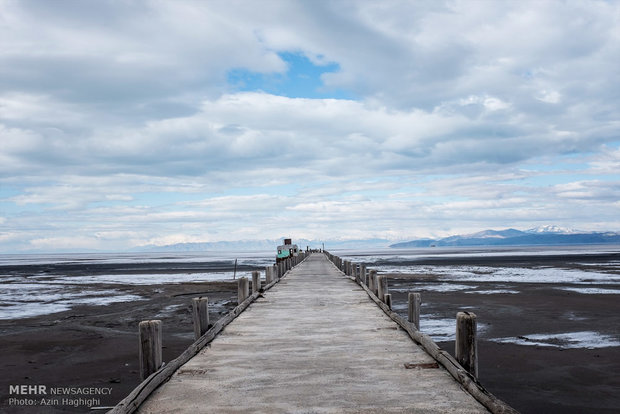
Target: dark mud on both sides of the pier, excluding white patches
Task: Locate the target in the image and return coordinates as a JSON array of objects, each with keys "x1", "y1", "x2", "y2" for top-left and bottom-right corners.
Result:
[{"x1": 0, "y1": 253, "x2": 620, "y2": 413}]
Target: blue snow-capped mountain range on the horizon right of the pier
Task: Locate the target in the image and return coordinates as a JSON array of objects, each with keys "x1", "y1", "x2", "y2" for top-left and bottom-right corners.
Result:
[{"x1": 390, "y1": 226, "x2": 620, "y2": 248}]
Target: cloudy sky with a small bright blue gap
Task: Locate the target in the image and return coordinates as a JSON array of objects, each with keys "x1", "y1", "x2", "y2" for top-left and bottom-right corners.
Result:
[{"x1": 0, "y1": 0, "x2": 620, "y2": 252}]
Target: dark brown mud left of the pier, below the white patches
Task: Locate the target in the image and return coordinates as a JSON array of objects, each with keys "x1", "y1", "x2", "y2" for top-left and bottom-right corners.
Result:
[{"x1": 0, "y1": 282, "x2": 237, "y2": 413}]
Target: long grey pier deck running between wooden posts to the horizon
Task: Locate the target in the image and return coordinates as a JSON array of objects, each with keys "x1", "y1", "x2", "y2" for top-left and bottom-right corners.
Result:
[{"x1": 134, "y1": 254, "x2": 488, "y2": 413}]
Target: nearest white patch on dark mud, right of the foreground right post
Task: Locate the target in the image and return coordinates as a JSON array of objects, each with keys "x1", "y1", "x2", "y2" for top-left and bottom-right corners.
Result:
[{"x1": 491, "y1": 331, "x2": 620, "y2": 349}]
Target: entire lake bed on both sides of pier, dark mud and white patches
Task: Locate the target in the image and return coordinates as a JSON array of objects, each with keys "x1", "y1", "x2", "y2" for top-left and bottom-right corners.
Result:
[{"x1": 0, "y1": 246, "x2": 620, "y2": 413}]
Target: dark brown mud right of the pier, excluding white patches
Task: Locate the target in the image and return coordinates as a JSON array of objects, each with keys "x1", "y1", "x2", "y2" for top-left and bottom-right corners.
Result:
[{"x1": 389, "y1": 266, "x2": 620, "y2": 414}]
